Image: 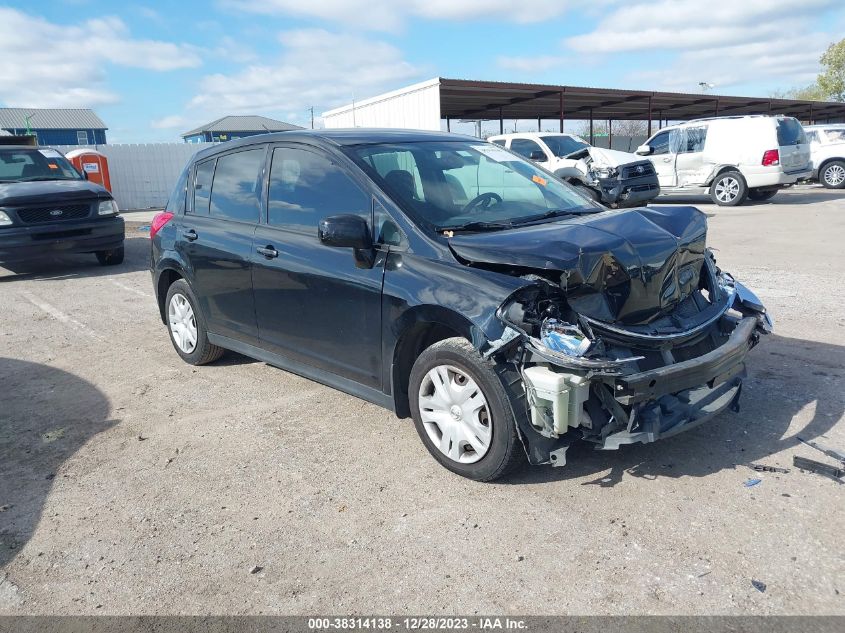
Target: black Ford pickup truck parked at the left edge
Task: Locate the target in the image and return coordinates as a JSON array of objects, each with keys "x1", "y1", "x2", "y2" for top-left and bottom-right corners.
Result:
[{"x1": 0, "y1": 146, "x2": 125, "y2": 266}]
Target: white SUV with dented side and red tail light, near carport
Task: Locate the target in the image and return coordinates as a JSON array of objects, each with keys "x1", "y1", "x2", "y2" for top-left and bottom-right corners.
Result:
[{"x1": 636, "y1": 115, "x2": 812, "y2": 206}]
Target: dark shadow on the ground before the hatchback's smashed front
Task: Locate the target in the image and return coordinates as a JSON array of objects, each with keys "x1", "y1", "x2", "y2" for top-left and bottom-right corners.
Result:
[{"x1": 501, "y1": 335, "x2": 845, "y2": 487}]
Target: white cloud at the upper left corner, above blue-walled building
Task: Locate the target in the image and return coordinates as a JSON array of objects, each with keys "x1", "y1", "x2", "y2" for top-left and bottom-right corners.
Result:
[{"x1": 0, "y1": 7, "x2": 201, "y2": 107}]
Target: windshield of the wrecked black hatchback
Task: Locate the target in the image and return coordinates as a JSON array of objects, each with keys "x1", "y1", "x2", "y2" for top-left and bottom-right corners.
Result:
[{"x1": 346, "y1": 140, "x2": 604, "y2": 231}]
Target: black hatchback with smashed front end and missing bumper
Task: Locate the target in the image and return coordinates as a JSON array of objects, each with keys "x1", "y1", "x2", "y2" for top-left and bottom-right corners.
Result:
[{"x1": 150, "y1": 129, "x2": 771, "y2": 480}]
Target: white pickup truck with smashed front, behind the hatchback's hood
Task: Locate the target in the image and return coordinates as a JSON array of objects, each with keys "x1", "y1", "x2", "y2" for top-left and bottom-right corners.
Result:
[{"x1": 487, "y1": 132, "x2": 660, "y2": 207}]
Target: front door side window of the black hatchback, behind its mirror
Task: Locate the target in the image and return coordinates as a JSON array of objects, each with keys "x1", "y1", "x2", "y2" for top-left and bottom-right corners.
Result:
[{"x1": 267, "y1": 147, "x2": 372, "y2": 234}]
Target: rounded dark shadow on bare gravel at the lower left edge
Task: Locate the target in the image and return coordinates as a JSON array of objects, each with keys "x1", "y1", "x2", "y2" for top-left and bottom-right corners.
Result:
[{"x1": 0, "y1": 357, "x2": 119, "y2": 569}]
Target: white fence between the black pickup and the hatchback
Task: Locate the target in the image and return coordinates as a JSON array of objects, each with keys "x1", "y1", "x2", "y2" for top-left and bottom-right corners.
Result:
[{"x1": 56, "y1": 143, "x2": 213, "y2": 210}]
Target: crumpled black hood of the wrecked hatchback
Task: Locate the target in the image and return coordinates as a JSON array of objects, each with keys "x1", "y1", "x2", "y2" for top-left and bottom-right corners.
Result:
[{"x1": 449, "y1": 206, "x2": 707, "y2": 325}]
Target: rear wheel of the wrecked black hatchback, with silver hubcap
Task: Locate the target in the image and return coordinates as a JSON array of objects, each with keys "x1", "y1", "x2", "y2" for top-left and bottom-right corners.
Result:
[{"x1": 165, "y1": 279, "x2": 225, "y2": 365}]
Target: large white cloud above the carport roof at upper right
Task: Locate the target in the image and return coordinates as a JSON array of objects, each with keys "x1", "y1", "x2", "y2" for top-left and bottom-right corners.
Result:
[{"x1": 564, "y1": 0, "x2": 841, "y2": 93}]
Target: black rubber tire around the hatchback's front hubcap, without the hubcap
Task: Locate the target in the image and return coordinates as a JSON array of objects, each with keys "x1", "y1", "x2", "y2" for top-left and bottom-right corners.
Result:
[{"x1": 408, "y1": 338, "x2": 525, "y2": 481}]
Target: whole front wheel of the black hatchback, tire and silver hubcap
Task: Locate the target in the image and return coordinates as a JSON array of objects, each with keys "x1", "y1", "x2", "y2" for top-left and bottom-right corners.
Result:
[{"x1": 408, "y1": 338, "x2": 525, "y2": 481}]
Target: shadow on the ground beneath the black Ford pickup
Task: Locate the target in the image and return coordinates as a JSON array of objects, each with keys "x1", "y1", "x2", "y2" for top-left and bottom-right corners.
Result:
[{"x1": 0, "y1": 228, "x2": 150, "y2": 283}]
